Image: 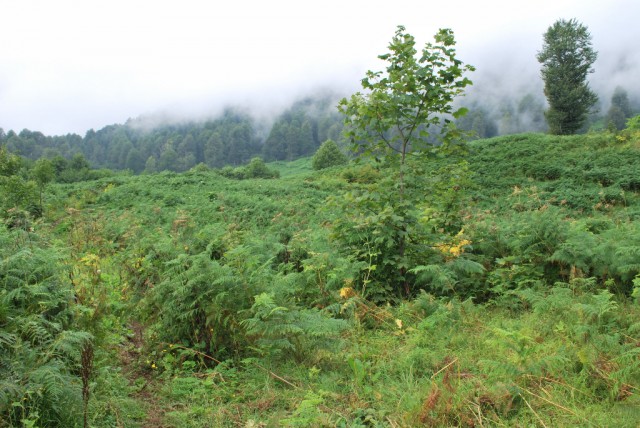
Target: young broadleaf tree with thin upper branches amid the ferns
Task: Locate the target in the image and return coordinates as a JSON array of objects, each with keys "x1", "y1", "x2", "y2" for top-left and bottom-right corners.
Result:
[{"x1": 335, "y1": 26, "x2": 473, "y2": 300}]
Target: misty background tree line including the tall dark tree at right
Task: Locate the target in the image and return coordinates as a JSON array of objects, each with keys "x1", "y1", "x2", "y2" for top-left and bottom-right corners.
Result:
[{"x1": 0, "y1": 19, "x2": 640, "y2": 172}]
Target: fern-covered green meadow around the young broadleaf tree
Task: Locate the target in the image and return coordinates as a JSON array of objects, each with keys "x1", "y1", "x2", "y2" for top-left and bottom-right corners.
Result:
[{"x1": 0, "y1": 122, "x2": 640, "y2": 426}]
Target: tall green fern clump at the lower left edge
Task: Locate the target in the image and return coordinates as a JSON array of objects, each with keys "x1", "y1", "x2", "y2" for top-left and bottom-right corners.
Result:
[{"x1": 0, "y1": 229, "x2": 92, "y2": 426}]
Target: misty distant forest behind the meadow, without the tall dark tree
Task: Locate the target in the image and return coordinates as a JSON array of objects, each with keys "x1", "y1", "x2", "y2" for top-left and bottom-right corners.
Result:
[{"x1": 0, "y1": 64, "x2": 640, "y2": 171}]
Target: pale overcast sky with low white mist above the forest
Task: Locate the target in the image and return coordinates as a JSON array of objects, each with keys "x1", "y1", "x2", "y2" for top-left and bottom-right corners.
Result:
[{"x1": 0, "y1": 0, "x2": 640, "y2": 135}]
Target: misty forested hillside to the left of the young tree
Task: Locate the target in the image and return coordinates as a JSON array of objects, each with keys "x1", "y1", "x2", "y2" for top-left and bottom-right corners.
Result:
[{"x1": 0, "y1": 95, "x2": 342, "y2": 174}]
